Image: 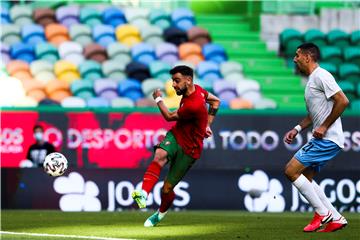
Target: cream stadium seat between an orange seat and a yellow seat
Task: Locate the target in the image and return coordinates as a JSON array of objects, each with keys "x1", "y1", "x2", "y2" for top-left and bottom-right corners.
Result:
[{"x1": 30, "y1": 60, "x2": 56, "y2": 84}]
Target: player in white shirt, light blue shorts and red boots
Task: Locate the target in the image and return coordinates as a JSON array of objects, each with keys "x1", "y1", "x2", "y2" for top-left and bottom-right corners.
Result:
[{"x1": 284, "y1": 43, "x2": 349, "y2": 232}]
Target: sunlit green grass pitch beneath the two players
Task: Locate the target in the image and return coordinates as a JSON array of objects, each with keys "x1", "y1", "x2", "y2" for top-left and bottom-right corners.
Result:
[{"x1": 1, "y1": 210, "x2": 360, "y2": 240}]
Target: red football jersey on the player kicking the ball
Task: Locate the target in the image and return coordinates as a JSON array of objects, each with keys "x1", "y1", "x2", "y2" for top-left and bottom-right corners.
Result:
[{"x1": 171, "y1": 84, "x2": 209, "y2": 159}]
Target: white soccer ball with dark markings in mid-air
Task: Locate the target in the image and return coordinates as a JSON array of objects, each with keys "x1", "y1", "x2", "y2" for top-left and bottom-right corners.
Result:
[{"x1": 43, "y1": 152, "x2": 68, "y2": 177}]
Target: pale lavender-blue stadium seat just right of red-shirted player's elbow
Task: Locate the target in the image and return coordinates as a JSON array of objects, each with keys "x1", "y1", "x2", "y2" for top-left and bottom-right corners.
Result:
[{"x1": 214, "y1": 81, "x2": 237, "y2": 107}]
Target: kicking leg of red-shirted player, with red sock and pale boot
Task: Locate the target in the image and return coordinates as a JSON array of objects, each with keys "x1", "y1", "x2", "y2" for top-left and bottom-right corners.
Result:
[{"x1": 131, "y1": 148, "x2": 168, "y2": 208}]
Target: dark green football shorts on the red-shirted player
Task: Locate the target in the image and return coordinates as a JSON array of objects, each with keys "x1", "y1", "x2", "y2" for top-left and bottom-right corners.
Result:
[{"x1": 157, "y1": 131, "x2": 195, "y2": 187}]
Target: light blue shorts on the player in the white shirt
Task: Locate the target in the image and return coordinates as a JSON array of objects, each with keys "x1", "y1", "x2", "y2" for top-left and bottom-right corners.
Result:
[{"x1": 294, "y1": 138, "x2": 341, "y2": 172}]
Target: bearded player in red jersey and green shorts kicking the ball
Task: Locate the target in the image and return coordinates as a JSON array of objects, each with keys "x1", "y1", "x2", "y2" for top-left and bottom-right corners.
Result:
[{"x1": 132, "y1": 66, "x2": 220, "y2": 227}]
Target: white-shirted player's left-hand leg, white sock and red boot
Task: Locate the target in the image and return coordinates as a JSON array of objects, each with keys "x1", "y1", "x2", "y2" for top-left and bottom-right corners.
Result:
[{"x1": 285, "y1": 158, "x2": 333, "y2": 232}]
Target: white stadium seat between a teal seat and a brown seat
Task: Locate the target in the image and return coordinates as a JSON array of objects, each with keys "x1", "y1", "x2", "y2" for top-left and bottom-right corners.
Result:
[{"x1": 59, "y1": 42, "x2": 84, "y2": 66}]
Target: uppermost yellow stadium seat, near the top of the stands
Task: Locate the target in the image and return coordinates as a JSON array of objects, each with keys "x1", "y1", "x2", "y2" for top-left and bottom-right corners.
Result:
[{"x1": 115, "y1": 24, "x2": 141, "y2": 47}]
